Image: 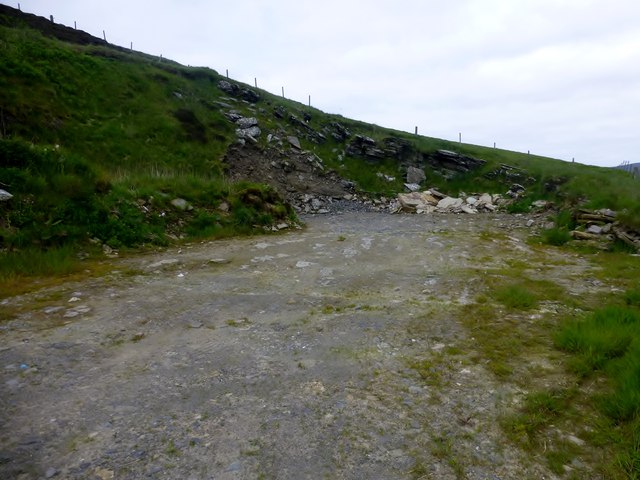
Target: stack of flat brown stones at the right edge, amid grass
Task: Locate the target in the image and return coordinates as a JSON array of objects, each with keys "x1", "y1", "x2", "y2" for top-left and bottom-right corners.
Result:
[{"x1": 571, "y1": 208, "x2": 640, "y2": 252}]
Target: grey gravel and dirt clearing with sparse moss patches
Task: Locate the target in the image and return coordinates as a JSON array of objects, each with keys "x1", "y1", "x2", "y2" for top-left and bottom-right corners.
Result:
[{"x1": 0, "y1": 214, "x2": 572, "y2": 479}]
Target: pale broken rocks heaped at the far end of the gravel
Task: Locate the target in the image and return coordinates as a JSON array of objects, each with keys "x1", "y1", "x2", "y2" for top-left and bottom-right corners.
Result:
[{"x1": 397, "y1": 188, "x2": 508, "y2": 214}]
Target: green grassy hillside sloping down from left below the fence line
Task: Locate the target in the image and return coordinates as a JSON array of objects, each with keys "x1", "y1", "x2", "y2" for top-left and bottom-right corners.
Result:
[{"x1": 0, "y1": 6, "x2": 640, "y2": 284}]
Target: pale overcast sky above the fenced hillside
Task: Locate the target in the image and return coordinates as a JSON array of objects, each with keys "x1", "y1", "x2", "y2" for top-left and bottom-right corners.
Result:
[{"x1": 15, "y1": 0, "x2": 640, "y2": 166}]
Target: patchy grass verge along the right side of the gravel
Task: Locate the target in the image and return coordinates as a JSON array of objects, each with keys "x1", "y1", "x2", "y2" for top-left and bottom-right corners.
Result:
[{"x1": 463, "y1": 244, "x2": 640, "y2": 479}]
